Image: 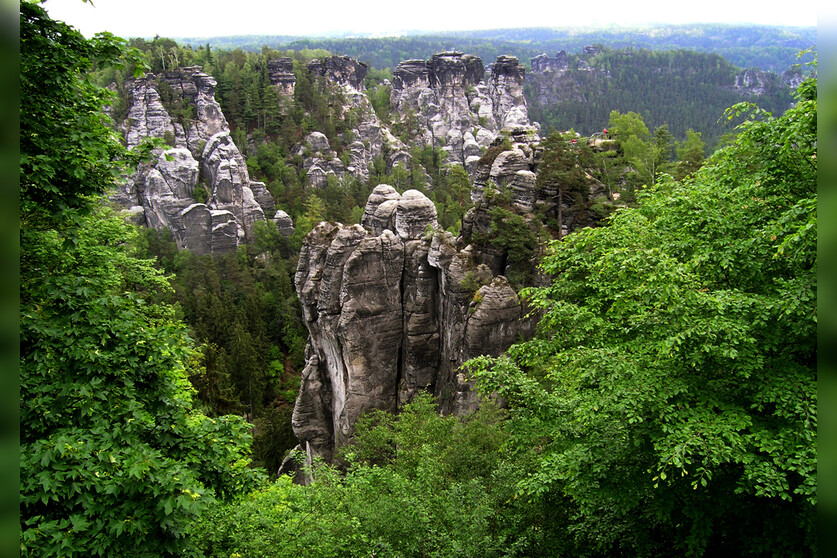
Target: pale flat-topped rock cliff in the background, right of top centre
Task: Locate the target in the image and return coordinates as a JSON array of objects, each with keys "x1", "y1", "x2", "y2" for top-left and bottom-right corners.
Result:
[{"x1": 391, "y1": 52, "x2": 537, "y2": 171}]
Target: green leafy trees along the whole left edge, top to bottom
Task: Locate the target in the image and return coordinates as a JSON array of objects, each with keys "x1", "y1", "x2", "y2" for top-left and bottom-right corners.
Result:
[{"x1": 20, "y1": 2, "x2": 258, "y2": 556}]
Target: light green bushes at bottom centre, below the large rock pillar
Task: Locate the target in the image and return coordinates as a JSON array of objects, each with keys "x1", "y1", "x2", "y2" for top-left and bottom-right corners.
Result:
[{"x1": 195, "y1": 395, "x2": 542, "y2": 558}]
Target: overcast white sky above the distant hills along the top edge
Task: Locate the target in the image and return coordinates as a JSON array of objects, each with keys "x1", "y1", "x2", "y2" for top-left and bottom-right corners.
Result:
[{"x1": 40, "y1": 0, "x2": 817, "y2": 38}]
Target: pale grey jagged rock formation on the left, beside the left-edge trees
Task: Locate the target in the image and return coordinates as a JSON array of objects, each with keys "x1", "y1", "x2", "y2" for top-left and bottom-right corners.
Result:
[{"x1": 112, "y1": 67, "x2": 275, "y2": 254}]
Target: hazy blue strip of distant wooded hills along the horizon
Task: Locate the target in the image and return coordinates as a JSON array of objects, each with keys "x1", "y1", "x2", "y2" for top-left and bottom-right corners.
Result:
[{"x1": 178, "y1": 24, "x2": 817, "y2": 73}]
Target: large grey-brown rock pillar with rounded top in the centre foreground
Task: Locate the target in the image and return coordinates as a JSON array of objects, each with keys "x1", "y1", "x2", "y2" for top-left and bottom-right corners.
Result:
[{"x1": 293, "y1": 185, "x2": 522, "y2": 468}]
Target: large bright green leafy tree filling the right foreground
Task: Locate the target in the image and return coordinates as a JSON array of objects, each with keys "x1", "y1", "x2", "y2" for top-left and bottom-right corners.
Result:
[{"x1": 473, "y1": 69, "x2": 817, "y2": 556}]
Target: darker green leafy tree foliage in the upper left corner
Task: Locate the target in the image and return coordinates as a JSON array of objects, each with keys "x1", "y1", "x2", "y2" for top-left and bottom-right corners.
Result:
[{"x1": 20, "y1": 1, "x2": 147, "y2": 225}]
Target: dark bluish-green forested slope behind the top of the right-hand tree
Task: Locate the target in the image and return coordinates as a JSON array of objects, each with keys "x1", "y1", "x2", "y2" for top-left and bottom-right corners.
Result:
[{"x1": 525, "y1": 45, "x2": 791, "y2": 147}]
